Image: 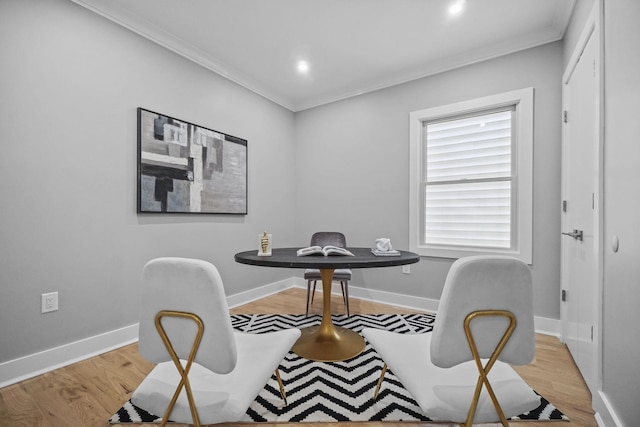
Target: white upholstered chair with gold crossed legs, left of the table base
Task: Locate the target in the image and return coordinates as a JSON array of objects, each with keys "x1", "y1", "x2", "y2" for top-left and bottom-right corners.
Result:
[{"x1": 131, "y1": 258, "x2": 300, "y2": 426}]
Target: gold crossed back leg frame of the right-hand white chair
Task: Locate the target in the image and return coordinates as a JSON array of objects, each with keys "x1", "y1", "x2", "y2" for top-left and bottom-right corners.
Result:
[{"x1": 464, "y1": 310, "x2": 517, "y2": 427}]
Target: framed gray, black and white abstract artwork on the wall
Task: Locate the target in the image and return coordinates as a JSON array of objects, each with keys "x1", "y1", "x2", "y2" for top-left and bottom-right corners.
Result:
[{"x1": 138, "y1": 108, "x2": 247, "y2": 215}]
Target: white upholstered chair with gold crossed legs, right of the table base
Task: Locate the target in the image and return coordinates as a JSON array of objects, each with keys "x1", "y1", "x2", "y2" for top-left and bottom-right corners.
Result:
[{"x1": 362, "y1": 256, "x2": 540, "y2": 426}]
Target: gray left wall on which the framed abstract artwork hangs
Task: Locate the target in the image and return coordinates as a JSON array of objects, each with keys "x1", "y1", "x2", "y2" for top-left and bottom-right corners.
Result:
[{"x1": 0, "y1": 0, "x2": 297, "y2": 362}]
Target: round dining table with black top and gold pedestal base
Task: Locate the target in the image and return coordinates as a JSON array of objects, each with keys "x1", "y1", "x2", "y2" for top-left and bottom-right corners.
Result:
[{"x1": 234, "y1": 248, "x2": 420, "y2": 362}]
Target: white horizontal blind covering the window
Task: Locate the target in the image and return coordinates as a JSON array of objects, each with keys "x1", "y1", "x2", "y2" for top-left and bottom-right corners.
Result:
[{"x1": 422, "y1": 107, "x2": 515, "y2": 249}]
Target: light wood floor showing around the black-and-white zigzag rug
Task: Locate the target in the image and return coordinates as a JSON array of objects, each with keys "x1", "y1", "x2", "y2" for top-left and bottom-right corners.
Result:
[{"x1": 0, "y1": 289, "x2": 597, "y2": 427}]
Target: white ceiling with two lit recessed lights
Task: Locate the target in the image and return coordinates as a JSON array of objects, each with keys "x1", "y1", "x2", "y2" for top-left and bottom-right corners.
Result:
[{"x1": 73, "y1": 0, "x2": 575, "y2": 111}]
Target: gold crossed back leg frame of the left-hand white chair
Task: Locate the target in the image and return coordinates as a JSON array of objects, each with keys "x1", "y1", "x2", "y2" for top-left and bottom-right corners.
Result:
[{"x1": 155, "y1": 310, "x2": 204, "y2": 427}]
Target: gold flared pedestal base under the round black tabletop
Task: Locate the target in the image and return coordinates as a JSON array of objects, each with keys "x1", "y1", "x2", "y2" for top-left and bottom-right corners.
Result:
[{"x1": 291, "y1": 268, "x2": 365, "y2": 362}]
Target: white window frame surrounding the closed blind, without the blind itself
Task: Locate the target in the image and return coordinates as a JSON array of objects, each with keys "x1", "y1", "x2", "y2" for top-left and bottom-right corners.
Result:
[{"x1": 409, "y1": 88, "x2": 534, "y2": 264}]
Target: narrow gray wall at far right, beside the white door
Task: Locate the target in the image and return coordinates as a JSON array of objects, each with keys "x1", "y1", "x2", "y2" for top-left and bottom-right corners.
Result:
[{"x1": 596, "y1": 0, "x2": 640, "y2": 426}]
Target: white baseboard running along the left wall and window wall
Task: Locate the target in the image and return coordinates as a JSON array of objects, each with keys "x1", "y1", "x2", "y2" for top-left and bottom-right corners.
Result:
[{"x1": 0, "y1": 277, "x2": 560, "y2": 388}]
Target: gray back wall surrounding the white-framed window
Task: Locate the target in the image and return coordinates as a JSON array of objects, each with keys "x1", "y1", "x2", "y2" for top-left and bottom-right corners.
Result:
[{"x1": 295, "y1": 42, "x2": 563, "y2": 319}]
